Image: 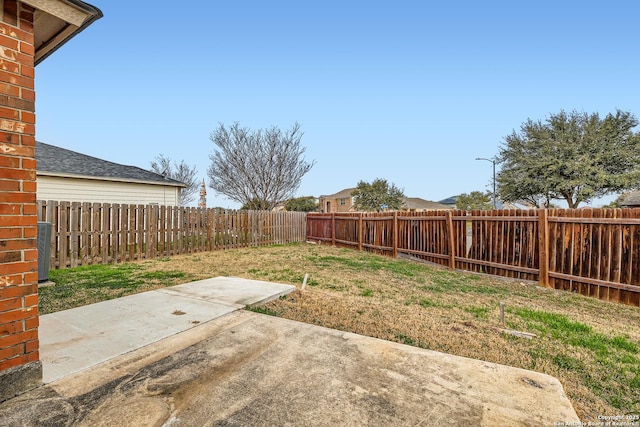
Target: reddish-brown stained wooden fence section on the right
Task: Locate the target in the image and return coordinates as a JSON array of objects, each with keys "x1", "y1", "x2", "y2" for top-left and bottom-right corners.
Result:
[{"x1": 307, "y1": 209, "x2": 640, "y2": 306}]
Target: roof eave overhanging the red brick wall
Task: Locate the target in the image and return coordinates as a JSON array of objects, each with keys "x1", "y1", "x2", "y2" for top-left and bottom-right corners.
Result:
[{"x1": 33, "y1": 0, "x2": 102, "y2": 65}]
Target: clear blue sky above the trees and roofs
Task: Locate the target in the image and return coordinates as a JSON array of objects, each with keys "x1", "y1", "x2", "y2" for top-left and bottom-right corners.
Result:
[{"x1": 36, "y1": 0, "x2": 640, "y2": 208}]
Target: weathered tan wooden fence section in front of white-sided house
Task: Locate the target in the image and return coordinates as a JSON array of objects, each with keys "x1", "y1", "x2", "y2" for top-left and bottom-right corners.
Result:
[{"x1": 38, "y1": 201, "x2": 306, "y2": 269}]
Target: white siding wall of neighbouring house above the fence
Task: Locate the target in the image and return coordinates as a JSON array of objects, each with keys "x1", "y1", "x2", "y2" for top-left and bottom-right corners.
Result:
[{"x1": 37, "y1": 175, "x2": 180, "y2": 206}]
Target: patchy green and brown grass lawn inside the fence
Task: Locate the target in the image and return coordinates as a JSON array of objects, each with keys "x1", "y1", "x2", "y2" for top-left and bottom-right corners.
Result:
[{"x1": 40, "y1": 244, "x2": 640, "y2": 422}]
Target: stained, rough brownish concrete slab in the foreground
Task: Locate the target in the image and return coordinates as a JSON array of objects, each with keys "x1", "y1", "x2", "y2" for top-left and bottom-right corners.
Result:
[{"x1": 0, "y1": 311, "x2": 579, "y2": 427}]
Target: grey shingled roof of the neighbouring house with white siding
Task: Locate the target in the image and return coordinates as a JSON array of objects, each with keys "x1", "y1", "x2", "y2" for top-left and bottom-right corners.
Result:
[{"x1": 36, "y1": 141, "x2": 186, "y2": 187}]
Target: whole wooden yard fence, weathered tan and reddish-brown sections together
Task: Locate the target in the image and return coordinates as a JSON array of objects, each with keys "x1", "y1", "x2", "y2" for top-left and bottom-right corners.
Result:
[{"x1": 37, "y1": 201, "x2": 640, "y2": 306}]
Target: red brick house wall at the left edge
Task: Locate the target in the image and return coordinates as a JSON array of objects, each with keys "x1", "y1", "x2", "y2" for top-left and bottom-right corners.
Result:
[{"x1": 0, "y1": 0, "x2": 41, "y2": 401}]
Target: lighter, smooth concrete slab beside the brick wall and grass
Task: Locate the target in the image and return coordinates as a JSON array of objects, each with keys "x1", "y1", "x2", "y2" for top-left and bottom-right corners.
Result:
[{"x1": 39, "y1": 277, "x2": 295, "y2": 383}]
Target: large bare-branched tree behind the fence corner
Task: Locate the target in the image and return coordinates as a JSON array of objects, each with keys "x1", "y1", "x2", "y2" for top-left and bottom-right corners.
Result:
[{"x1": 207, "y1": 122, "x2": 315, "y2": 210}]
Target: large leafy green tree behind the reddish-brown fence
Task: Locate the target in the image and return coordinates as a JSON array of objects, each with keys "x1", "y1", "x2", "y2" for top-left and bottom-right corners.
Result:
[{"x1": 496, "y1": 110, "x2": 640, "y2": 208}]
